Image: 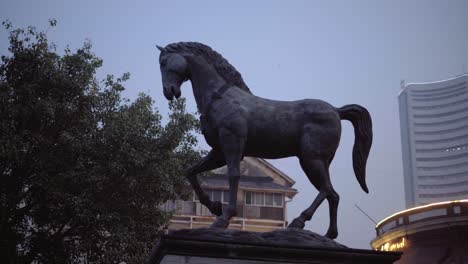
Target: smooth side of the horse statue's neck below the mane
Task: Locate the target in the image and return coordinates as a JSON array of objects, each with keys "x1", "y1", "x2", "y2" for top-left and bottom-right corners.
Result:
[{"x1": 190, "y1": 59, "x2": 226, "y2": 113}]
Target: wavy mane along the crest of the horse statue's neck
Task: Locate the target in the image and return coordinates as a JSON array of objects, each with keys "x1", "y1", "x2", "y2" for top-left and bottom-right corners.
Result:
[{"x1": 165, "y1": 42, "x2": 252, "y2": 94}]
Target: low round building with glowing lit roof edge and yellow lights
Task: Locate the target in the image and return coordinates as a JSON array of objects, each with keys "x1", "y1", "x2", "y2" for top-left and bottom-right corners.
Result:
[{"x1": 371, "y1": 200, "x2": 468, "y2": 264}]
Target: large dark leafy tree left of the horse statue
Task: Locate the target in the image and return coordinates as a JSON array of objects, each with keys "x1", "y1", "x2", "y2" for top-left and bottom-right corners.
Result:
[{"x1": 0, "y1": 20, "x2": 200, "y2": 263}]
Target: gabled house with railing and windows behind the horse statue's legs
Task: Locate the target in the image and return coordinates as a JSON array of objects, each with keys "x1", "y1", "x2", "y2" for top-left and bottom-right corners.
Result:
[{"x1": 164, "y1": 157, "x2": 297, "y2": 232}]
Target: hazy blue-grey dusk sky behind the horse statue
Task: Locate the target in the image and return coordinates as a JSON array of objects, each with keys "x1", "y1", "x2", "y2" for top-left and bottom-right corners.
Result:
[{"x1": 0, "y1": 0, "x2": 468, "y2": 248}]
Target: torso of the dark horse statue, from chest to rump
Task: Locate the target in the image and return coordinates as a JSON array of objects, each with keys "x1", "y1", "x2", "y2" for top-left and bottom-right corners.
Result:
[{"x1": 201, "y1": 87, "x2": 341, "y2": 159}]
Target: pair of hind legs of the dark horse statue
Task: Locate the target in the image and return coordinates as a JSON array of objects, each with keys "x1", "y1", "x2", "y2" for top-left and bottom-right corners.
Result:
[{"x1": 288, "y1": 158, "x2": 338, "y2": 238}]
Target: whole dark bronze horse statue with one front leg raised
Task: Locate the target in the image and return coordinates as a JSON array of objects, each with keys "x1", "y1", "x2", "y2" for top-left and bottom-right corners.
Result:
[{"x1": 158, "y1": 42, "x2": 372, "y2": 239}]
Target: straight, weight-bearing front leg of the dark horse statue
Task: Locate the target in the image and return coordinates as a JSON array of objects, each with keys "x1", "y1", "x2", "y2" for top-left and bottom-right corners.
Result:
[{"x1": 211, "y1": 129, "x2": 245, "y2": 228}]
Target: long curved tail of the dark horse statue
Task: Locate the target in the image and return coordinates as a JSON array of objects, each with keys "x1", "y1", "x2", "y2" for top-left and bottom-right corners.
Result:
[{"x1": 336, "y1": 104, "x2": 372, "y2": 193}]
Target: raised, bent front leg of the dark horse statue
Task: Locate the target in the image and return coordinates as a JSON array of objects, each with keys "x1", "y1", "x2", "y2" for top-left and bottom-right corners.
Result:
[{"x1": 187, "y1": 150, "x2": 226, "y2": 216}]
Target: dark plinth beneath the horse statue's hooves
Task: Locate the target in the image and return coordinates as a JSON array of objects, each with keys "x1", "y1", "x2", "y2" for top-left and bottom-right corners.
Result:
[{"x1": 148, "y1": 228, "x2": 401, "y2": 264}]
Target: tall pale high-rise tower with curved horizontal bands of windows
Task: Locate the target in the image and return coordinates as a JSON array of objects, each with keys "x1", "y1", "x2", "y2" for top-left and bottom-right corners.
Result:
[{"x1": 398, "y1": 74, "x2": 468, "y2": 208}]
